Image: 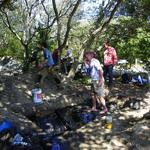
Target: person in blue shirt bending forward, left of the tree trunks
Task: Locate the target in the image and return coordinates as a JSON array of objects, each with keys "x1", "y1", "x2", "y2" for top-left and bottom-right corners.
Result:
[{"x1": 39, "y1": 42, "x2": 54, "y2": 85}]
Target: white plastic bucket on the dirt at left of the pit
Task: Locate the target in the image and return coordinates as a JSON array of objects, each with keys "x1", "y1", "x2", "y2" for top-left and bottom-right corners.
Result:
[{"x1": 32, "y1": 88, "x2": 42, "y2": 103}]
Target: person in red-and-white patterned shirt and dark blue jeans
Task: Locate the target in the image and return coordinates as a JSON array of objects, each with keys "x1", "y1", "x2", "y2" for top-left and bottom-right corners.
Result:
[{"x1": 104, "y1": 41, "x2": 117, "y2": 86}]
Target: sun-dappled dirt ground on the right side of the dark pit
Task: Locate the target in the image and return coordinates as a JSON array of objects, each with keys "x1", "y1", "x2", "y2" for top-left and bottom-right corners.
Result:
[{"x1": 56, "y1": 81, "x2": 150, "y2": 150}]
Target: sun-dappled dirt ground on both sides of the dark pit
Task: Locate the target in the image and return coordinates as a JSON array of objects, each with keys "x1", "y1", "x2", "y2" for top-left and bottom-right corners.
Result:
[{"x1": 0, "y1": 59, "x2": 150, "y2": 150}]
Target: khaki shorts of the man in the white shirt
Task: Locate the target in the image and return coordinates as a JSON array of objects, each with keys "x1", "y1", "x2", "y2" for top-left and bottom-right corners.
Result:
[{"x1": 91, "y1": 81, "x2": 105, "y2": 97}]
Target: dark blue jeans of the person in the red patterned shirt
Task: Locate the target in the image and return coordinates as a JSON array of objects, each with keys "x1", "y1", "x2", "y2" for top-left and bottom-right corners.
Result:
[{"x1": 104, "y1": 65, "x2": 113, "y2": 85}]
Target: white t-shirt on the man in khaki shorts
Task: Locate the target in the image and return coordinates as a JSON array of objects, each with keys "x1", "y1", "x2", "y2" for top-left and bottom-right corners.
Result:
[{"x1": 86, "y1": 58, "x2": 104, "y2": 81}]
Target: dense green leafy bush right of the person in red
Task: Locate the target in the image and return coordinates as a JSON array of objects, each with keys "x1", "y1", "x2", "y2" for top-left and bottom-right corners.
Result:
[{"x1": 100, "y1": 17, "x2": 150, "y2": 64}]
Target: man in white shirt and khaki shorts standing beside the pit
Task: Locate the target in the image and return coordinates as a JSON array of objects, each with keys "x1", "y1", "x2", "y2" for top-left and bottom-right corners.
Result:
[{"x1": 84, "y1": 52, "x2": 108, "y2": 114}]
